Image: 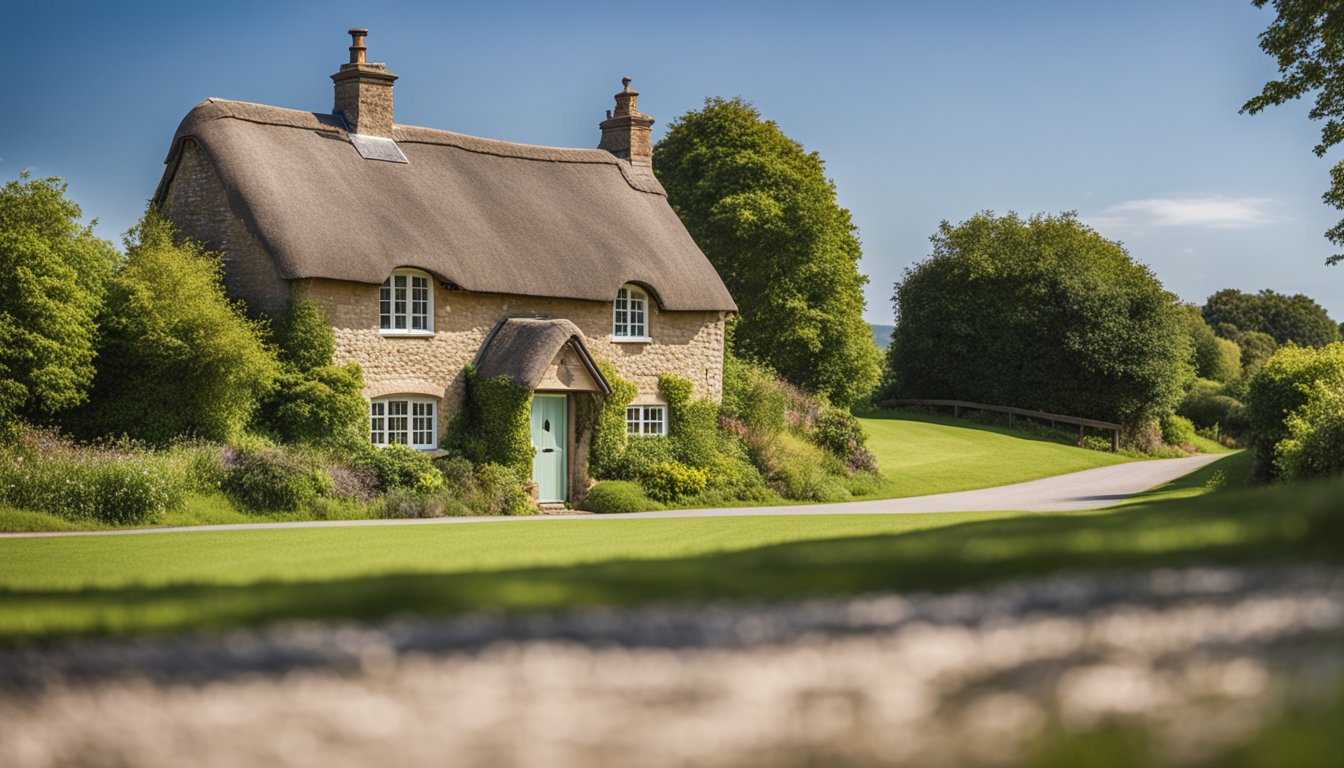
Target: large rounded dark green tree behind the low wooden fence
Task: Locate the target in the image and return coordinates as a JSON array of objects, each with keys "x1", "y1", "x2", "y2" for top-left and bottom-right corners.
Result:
[{"x1": 886, "y1": 213, "x2": 1193, "y2": 426}]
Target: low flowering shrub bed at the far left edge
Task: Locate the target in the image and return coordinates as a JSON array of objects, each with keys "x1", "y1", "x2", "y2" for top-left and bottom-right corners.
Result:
[{"x1": 0, "y1": 432, "x2": 191, "y2": 526}]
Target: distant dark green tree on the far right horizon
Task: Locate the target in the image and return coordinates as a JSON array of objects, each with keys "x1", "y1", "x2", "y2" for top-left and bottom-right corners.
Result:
[{"x1": 1203, "y1": 288, "x2": 1340, "y2": 347}]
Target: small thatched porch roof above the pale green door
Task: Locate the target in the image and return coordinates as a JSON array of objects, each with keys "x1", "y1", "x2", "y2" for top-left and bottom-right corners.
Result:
[{"x1": 474, "y1": 317, "x2": 612, "y2": 394}]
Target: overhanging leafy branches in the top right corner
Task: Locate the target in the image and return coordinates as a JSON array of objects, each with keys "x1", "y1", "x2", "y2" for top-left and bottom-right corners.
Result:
[{"x1": 1242, "y1": 0, "x2": 1344, "y2": 264}]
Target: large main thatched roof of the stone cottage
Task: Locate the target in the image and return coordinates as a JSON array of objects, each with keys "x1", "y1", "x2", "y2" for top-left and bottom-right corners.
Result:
[{"x1": 156, "y1": 100, "x2": 737, "y2": 311}]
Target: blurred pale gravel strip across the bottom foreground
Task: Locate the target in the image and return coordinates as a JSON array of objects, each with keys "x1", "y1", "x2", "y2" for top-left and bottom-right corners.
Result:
[{"x1": 0, "y1": 568, "x2": 1344, "y2": 768}]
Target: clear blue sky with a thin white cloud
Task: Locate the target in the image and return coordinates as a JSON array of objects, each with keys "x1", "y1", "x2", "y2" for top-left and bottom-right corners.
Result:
[{"x1": 0, "y1": 0, "x2": 1344, "y2": 323}]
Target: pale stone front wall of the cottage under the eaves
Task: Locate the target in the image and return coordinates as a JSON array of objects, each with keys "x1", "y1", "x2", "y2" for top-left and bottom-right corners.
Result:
[{"x1": 294, "y1": 280, "x2": 723, "y2": 428}]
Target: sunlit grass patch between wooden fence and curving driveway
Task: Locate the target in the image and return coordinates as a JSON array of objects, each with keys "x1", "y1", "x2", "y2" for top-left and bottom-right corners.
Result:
[{"x1": 859, "y1": 410, "x2": 1134, "y2": 499}]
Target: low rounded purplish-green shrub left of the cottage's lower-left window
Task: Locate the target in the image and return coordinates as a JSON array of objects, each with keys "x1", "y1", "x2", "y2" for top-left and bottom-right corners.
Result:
[{"x1": 220, "y1": 448, "x2": 333, "y2": 512}]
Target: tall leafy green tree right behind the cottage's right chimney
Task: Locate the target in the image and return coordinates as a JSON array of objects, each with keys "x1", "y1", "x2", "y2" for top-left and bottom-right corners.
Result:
[{"x1": 653, "y1": 98, "x2": 879, "y2": 405}]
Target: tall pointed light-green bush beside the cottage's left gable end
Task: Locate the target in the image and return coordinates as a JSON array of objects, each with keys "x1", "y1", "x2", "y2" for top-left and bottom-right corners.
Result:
[{"x1": 70, "y1": 211, "x2": 278, "y2": 444}]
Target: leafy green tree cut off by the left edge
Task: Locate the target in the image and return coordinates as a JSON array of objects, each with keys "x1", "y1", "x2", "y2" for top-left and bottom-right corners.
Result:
[{"x1": 0, "y1": 174, "x2": 117, "y2": 426}]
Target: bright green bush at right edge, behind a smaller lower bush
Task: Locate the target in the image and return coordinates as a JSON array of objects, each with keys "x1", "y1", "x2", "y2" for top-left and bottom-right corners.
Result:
[{"x1": 1246, "y1": 343, "x2": 1344, "y2": 480}]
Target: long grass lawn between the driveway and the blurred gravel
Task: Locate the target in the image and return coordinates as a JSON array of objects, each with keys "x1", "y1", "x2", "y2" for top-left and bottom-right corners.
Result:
[{"x1": 0, "y1": 457, "x2": 1344, "y2": 642}]
